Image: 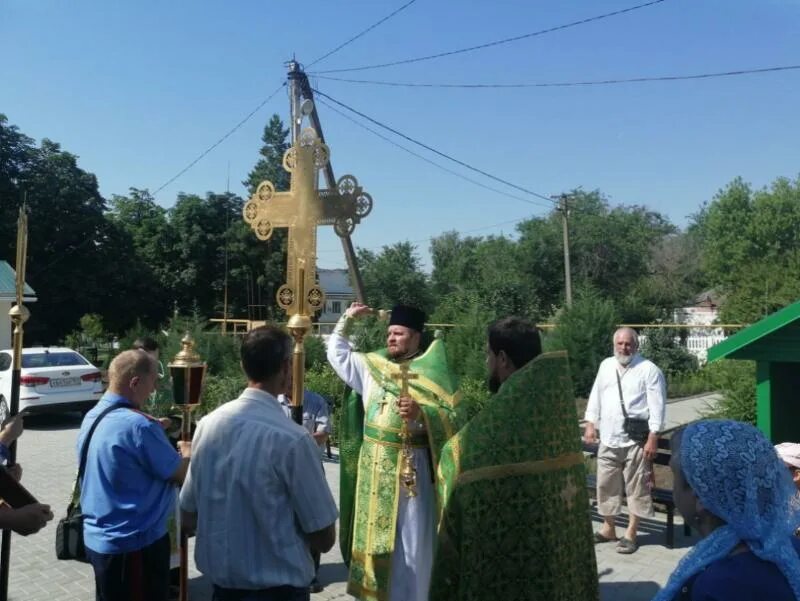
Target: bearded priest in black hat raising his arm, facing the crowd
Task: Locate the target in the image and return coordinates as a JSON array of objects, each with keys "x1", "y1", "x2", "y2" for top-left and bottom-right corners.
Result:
[{"x1": 328, "y1": 303, "x2": 461, "y2": 601}]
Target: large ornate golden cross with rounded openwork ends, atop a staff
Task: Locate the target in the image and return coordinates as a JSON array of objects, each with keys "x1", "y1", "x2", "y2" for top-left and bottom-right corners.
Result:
[{"x1": 244, "y1": 127, "x2": 372, "y2": 316}]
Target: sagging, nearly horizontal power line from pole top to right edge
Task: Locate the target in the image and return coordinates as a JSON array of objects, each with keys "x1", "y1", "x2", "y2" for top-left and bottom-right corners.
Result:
[{"x1": 314, "y1": 65, "x2": 800, "y2": 88}]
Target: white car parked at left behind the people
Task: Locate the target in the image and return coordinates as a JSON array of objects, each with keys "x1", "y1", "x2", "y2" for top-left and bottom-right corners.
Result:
[{"x1": 0, "y1": 346, "x2": 103, "y2": 417}]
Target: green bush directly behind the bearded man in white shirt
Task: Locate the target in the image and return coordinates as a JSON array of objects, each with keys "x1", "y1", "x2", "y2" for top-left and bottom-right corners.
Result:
[{"x1": 547, "y1": 291, "x2": 619, "y2": 396}]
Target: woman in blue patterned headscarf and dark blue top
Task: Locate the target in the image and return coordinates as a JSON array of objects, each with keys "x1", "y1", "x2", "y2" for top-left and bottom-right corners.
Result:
[{"x1": 653, "y1": 420, "x2": 800, "y2": 601}]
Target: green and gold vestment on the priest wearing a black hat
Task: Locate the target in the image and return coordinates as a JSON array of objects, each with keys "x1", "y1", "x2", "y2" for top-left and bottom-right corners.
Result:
[{"x1": 340, "y1": 340, "x2": 460, "y2": 601}]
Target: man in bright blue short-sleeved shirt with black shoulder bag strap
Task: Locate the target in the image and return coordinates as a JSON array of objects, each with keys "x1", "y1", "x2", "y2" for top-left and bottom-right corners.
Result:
[{"x1": 77, "y1": 350, "x2": 191, "y2": 601}]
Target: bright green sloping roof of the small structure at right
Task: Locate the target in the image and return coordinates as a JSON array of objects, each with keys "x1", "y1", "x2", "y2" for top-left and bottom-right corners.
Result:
[{"x1": 708, "y1": 301, "x2": 800, "y2": 363}]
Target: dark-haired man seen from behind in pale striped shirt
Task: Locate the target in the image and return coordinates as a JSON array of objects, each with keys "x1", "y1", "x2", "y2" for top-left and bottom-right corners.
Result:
[{"x1": 180, "y1": 326, "x2": 337, "y2": 601}]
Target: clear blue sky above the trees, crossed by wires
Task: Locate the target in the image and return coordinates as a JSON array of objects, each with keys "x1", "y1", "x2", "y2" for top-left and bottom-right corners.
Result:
[{"x1": 0, "y1": 0, "x2": 800, "y2": 268}]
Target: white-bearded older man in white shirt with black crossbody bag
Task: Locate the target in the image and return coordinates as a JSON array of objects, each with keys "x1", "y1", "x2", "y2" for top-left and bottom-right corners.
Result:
[{"x1": 584, "y1": 328, "x2": 667, "y2": 554}]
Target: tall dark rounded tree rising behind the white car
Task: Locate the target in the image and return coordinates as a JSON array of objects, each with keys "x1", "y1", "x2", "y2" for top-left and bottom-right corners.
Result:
[{"x1": 12, "y1": 139, "x2": 126, "y2": 343}]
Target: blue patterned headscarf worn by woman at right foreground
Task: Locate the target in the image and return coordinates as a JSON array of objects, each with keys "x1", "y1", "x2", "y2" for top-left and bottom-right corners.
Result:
[{"x1": 653, "y1": 420, "x2": 800, "y2": 601}]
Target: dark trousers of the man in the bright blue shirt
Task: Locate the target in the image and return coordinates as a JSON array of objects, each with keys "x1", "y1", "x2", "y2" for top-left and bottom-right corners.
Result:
[{"x1": 86, "y1": 534, "x2": 170, "y2": 601}]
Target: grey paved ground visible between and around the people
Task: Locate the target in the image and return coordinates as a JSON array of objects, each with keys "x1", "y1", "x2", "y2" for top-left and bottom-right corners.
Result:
[{"x1": 9, "y1": 397, "x2": 708, "y2": 601}]
